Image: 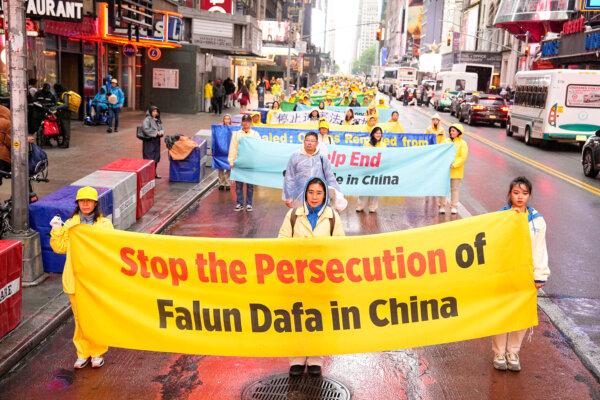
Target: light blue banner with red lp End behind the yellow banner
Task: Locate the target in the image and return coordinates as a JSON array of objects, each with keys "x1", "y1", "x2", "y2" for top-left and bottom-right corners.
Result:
[{"x1": 231, "y1": 138, "x2": 456, "y2": 196}]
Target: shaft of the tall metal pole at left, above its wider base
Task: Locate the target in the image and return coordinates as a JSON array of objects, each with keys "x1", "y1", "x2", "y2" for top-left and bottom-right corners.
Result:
[{"x1": 6, "y1": 0, "x2": 29, "y2": 233}]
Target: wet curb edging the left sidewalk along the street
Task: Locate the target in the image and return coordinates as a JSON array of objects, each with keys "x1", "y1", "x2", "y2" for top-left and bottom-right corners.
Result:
[{"x1": 0, "y1": 171, "x2": 217, "y2": 379}]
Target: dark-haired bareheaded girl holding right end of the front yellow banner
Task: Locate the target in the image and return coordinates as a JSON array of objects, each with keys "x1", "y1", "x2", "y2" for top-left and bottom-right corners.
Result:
[{"x1": 492, "y1": 176, "x2": 550, "y2": 372}]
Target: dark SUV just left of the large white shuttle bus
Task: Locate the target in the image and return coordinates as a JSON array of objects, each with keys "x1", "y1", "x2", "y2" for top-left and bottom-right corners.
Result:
[{"x1": 458, "y1": 94, "x2": 508, "y2": 128}]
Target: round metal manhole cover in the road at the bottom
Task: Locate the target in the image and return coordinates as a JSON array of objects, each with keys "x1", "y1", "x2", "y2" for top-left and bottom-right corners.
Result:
[{"x1": 242, "y1": 374, "x2": 351, "y2": 400}]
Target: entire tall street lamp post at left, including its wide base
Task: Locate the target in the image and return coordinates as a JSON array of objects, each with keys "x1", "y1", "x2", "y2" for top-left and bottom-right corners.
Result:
[{"x1": 5, "y1": 0, "x2": 45, "y2": 286}]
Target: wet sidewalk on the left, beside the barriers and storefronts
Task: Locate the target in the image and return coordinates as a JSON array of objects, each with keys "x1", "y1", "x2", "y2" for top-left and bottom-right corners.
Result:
[{"x1": 0, "y1": 104, "x2": 239, "y2": 376}]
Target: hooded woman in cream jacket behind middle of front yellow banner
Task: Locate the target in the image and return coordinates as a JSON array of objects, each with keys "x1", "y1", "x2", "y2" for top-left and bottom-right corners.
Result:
[{"x1": 277, "y1": 177, "x2": 345, "y2": 377}]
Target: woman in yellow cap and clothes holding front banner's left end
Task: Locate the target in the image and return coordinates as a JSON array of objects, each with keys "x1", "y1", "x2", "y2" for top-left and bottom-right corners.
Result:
[{"x1": 50, "y1": 186, "x2": 114, "y2": 369}]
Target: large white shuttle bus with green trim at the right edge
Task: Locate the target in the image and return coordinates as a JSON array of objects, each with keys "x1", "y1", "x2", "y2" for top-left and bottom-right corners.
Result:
[{"x1": 506, "y1": 69, "x2": 600, "y2": 145}]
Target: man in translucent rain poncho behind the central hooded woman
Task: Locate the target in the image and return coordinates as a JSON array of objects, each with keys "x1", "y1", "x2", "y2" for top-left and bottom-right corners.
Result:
[{"x1": 283, "y1": 132, "x2": 341, "y2": 207}]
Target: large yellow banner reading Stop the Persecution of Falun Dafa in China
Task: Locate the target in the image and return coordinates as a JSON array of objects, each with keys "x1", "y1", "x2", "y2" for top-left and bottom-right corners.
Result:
[{"x1": 69, "y1": 211, "x2": 537, "y2": 357}]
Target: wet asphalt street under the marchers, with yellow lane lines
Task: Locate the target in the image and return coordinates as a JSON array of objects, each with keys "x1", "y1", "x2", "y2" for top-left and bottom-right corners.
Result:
[{"x1": 0, "y1": 102, "x2": 600, "y2": 400}]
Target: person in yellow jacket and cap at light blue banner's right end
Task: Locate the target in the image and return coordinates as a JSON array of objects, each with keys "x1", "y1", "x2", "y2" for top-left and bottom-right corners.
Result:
[{"x1": 439, "y1": 124, "x2": 469, "y2": 214}]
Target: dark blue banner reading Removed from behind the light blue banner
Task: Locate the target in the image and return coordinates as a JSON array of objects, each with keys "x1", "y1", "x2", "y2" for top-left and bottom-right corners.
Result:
[{"x1": 212, "y1": 125, "x2": 436, "y2": 169}]
